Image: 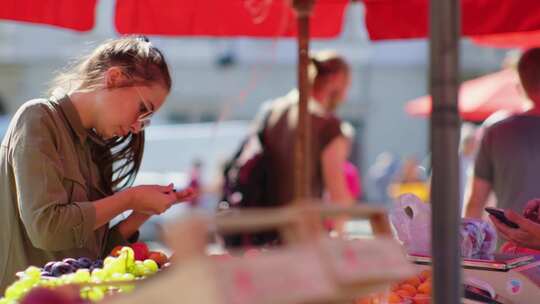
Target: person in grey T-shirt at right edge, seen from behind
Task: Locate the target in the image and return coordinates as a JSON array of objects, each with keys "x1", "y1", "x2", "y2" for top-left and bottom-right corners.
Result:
[{"x1": 465, "y1": 48, "x2": 540, "y2": 218}]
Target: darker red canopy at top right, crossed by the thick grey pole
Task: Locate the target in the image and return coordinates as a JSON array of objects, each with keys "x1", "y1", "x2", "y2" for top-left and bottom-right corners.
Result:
[{"x1": 364, "y1": 0, "x2": 540, "y2": 40}]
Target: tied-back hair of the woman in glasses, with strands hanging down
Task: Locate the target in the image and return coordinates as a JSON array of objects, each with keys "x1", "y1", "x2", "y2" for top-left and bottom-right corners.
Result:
[{"x1": 50, "y1": 36, "x2": 172, "y2": 194}]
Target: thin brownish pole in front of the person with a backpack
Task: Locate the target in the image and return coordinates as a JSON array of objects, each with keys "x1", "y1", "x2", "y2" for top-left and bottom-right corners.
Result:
[{"x1": 293, "y1": 0, "x2": 314, "y2": 202}]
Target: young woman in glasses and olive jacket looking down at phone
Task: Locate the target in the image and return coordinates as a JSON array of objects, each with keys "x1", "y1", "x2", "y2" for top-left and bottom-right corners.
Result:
[{"x1": 0, "y1": 37, "x2": 190, "y2": 290}]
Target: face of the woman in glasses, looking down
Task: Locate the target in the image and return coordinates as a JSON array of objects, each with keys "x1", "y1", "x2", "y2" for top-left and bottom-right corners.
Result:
[{"x1": 94, "y1": 79, "x2": 169, "y2": 139}]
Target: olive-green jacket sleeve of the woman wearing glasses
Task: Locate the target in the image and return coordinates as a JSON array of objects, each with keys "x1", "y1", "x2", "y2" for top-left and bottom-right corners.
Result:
[{"x1": 10, "y1": 105, "x2": 96, "y2": 251}]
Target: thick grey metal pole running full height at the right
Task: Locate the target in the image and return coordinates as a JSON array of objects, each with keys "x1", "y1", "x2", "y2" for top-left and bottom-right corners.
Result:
[{"x1": 430, "y1": 0, "x2": 462, "y2": 304}]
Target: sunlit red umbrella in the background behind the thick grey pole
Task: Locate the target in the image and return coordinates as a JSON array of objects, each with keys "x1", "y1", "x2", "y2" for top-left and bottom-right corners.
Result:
[{"x1": 405, "y1": 69, "x2": 530, "y2": 121}]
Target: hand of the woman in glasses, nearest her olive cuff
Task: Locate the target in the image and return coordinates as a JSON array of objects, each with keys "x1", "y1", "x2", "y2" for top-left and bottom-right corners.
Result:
[{"x1": 125, "y1": 184, "x2": 178, "y2": 215}]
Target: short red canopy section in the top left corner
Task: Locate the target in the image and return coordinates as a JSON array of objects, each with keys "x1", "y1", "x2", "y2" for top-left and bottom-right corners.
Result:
[{"x1": 0, "y1": 0, "x2": 97, "y2": 31}]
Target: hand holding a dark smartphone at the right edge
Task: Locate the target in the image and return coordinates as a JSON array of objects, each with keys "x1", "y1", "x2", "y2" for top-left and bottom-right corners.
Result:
[{"x1": 489, "y1": 199, "x2": 540, "y2": 250}]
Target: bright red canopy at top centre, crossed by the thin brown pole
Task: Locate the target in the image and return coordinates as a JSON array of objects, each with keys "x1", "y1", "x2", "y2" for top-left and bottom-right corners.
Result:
[{"x1": 115, "y1": 0, "x2": 349, "y2": 38}]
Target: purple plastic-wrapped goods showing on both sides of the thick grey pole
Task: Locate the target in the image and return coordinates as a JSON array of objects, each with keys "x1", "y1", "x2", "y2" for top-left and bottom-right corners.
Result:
[{"x1": 390, "y1": 194, "x2": 497, "y2": 258}]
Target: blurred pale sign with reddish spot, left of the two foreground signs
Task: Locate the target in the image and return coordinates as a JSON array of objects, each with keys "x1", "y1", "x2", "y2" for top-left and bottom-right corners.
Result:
[{"x1": 216, "y1": 246, "x2": 336, "y2": 304}]
